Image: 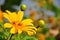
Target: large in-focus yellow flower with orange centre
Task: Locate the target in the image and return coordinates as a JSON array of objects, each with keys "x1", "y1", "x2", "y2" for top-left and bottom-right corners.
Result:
[{"x1": 4, "y1": 10, "x2": 37, "y2": 35}]
